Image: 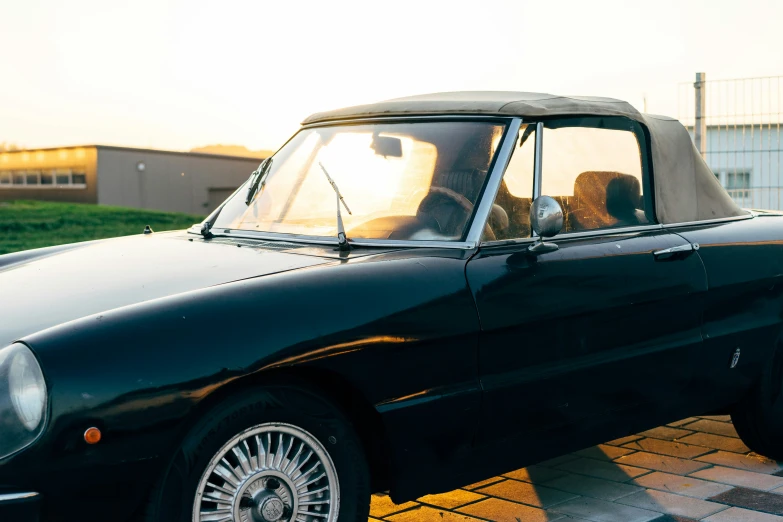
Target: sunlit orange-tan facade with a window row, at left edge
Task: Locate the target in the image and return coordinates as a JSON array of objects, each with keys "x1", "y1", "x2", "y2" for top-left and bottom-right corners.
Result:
[{"x1": 0, "y1": 147, "x2": 98, "y2": 203}]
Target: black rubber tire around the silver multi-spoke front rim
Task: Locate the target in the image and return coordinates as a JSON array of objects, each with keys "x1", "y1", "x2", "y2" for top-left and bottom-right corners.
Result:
[{"x1": 144, "y1": 385, "x2": 370, "y2": 522}]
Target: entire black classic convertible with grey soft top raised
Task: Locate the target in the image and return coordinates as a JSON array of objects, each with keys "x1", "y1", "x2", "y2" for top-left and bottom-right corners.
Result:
[{"x1": 0, "y1": 92, "x2": 783, "y2": 522}]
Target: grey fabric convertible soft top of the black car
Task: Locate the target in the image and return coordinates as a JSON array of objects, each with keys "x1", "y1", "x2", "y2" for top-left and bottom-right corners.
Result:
[{"x1": 302, "y1": 91, "x2": 747, "y2": 224}]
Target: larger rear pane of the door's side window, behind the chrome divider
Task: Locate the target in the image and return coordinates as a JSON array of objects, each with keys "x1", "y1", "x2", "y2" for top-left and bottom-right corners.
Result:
[{"x1": 541, "y1": 120, "x2": 650, "y2": 232}]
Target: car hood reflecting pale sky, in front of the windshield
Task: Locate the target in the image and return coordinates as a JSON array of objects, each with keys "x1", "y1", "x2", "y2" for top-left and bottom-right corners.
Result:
[{"x1": 0, "y1": 232, "x2": 333, "y2": 348}]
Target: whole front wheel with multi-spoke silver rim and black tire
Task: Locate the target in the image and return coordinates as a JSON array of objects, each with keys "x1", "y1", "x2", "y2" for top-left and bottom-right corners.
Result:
[{"x1": 146, "y1": 386, "x2": 370, "y2": 522}]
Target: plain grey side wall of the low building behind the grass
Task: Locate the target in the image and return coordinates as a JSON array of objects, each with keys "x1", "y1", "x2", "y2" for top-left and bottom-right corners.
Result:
[{"x1": 98, "y1": 146, "x2": 261, "y2": 215}]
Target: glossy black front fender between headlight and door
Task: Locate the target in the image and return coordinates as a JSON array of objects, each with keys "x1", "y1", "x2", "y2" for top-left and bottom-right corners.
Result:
[{"x1": 0, "y1": 254, "x2": 479, "y2": 504}]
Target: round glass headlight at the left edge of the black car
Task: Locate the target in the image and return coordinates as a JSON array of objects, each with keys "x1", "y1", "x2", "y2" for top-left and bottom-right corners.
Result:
[{"x1": 0, "y1": 344, "x2": 47, "y2": 458}]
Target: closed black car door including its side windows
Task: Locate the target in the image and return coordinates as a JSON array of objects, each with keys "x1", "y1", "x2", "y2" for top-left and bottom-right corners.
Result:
[{"x1": 466, "y1": 118, "x2": 707, "y2": 450}]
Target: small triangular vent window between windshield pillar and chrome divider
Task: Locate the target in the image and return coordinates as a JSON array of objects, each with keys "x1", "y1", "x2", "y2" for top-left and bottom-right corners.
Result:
[{"x1": 483, "y1": 124, "x2": 536, "y2": 241}]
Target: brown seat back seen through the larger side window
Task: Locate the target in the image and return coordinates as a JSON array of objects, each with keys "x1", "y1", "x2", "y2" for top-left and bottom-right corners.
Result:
[{"x1": 568, "y1": 171, "x2": 646, "y2": 231}]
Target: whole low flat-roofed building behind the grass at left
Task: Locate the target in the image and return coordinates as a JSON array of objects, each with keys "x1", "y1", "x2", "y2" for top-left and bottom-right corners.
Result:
[{"x1": 0, "y1": 145, "x2": 261, "y2": 214}]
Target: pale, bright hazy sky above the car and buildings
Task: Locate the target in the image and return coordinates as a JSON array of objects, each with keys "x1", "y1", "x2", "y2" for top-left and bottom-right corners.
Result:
[{"x1": 0, "y1": 0, "x2": 783, "y2": 150}]
